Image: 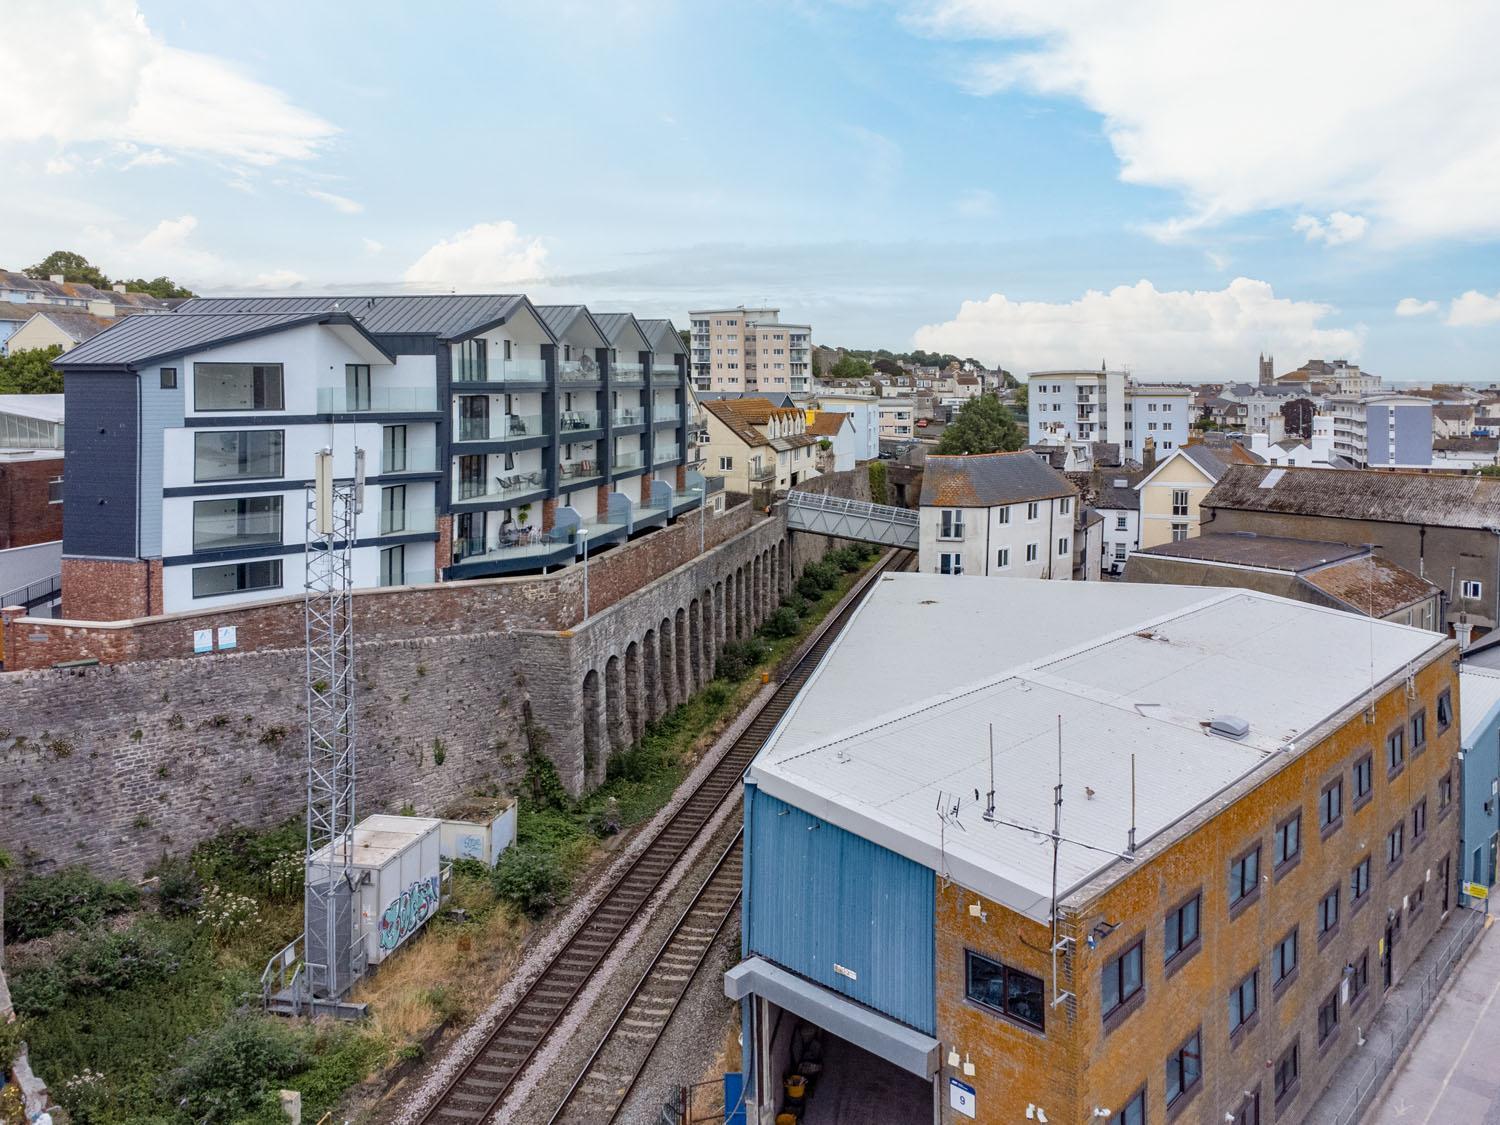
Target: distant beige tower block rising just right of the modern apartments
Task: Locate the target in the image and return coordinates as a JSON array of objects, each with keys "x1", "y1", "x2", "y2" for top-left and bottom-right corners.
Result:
[{"x1": 689, "y1": 306, "x2": 813, "y2": 395}]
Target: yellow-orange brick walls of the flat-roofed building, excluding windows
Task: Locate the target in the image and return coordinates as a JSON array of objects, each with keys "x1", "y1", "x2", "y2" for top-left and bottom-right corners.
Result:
[{"x1": 936, "y1": 638, "x2": 1460, "y2": 1125}]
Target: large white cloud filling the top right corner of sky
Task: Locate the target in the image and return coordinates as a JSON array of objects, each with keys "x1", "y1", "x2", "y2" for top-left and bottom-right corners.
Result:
[{"x1": 909, "y1": 0, "x2": 1500, "y2": 240}]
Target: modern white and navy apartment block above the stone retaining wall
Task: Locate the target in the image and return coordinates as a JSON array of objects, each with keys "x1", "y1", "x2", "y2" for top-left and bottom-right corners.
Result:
[{"x1": 49, "y1": 296, "x2": 708, "y2": 620}]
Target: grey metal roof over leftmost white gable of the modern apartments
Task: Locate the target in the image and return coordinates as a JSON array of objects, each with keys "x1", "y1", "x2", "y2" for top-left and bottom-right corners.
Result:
[{"x1": 54, "y1": 312, "x2": 393, "y2": 371}]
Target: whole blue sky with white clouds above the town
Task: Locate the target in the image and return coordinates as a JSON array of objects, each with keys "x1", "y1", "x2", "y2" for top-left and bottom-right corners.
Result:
[{"x1": 0, "y1": 0, "x2": 1500, "y2": 381}]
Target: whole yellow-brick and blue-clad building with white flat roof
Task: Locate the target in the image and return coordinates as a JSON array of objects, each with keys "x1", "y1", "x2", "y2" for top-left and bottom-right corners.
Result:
[{"x1": 725, "y1": 573, "x2": 1460, "y2": 1125}]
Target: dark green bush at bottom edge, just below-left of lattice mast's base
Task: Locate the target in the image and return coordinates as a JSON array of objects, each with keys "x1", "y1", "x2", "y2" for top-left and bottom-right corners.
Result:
[{"x1": 162, "y1": 1016, "x2": 309, "y2": 1121}]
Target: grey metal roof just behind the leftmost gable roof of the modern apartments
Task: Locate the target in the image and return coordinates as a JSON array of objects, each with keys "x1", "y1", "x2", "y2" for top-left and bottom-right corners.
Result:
[{"x1": 177, "y1": 293, "x2": 527, "y2": 341}]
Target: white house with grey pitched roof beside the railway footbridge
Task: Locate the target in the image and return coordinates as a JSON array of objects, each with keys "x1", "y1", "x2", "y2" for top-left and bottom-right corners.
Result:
[{"x1": 918, "y1": 450, "x2": 1079, "y2": 581}]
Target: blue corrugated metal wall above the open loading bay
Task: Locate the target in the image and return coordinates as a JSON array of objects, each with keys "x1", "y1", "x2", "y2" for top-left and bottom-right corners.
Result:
[{"x1": 743, "y1": 785, "x2": 938, "y2": 1035}]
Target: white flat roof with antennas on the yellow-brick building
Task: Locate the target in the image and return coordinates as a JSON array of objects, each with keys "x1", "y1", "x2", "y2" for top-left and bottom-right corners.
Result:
[{"x1": 749, "y1": 575, "x2": 1446, "y2": 921}]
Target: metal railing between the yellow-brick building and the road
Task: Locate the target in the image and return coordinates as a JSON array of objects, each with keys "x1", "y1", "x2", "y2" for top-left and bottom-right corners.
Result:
[{"x1": 1308, "y1": 909, "x2": 1485, "y2": 1125}]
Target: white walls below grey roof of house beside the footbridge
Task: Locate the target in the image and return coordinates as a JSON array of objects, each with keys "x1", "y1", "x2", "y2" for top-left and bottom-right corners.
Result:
[{"x1": 918, "y1": 497, "x2": 1079, "y2": 581}]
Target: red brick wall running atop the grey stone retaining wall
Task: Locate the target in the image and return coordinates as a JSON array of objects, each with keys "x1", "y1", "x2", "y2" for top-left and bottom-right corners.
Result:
[{"x1": 0, "y1": 504, "x2": 755, "y2": 672}]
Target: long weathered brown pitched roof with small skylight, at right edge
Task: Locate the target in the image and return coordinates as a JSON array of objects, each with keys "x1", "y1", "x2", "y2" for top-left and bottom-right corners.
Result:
[{"x1": 1203, "y1": 465, "x2": 1500, "y2": 528}]
